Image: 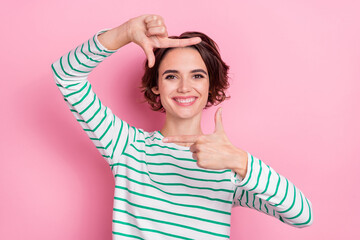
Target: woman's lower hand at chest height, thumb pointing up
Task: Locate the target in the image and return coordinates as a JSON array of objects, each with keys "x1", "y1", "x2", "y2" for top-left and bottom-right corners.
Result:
[{"x1": 163, "y1": 108, "x2": 248, "y2": 178}]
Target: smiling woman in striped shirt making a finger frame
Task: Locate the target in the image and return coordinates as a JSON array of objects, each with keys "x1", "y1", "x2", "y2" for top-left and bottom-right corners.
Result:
[{"x1": 52, "y1": 15, "x2": 312, "y2": 239}]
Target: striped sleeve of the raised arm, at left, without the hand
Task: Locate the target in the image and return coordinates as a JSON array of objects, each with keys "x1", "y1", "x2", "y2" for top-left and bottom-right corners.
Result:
[{"x1": 51, "y1": 31, "x2": 136, "y2": 164}]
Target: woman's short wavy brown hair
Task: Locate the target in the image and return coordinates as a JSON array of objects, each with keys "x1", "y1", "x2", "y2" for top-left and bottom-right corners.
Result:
[{"x1": 141, "y1": 32, "x2": 229, "y2": 112}]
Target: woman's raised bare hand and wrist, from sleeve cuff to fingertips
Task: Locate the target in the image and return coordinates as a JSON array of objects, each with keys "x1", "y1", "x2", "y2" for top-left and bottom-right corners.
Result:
[{"x1": 98, "y1": 15, "x2": 201, "y2": 68}]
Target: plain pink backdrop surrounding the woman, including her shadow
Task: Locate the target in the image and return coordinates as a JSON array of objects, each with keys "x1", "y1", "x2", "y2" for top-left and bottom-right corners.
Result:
[{"x1": 0, "y1": 0, "x2": 360, "y2": 240}]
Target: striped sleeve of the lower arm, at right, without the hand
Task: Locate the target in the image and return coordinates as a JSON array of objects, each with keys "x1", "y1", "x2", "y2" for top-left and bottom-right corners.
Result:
[{"x1": 231, "y1": 153, "x2": 313, "y2": 228}]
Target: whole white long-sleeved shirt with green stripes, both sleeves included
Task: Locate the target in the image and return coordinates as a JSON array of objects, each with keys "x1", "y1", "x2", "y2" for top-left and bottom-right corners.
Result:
[{"x1": 52, "y1": 32, "x2": 312, "y2": 240}]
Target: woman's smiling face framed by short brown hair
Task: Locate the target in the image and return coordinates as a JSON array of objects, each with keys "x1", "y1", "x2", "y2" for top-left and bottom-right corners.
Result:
[{"x1": 152, "y1": 47, "x2": 209, "y2": 119}]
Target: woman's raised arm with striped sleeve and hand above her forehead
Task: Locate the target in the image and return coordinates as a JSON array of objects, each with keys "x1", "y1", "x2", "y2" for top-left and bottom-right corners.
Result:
[{"x1": 51, "y1": 15, "x2": 199, "y2": 164}]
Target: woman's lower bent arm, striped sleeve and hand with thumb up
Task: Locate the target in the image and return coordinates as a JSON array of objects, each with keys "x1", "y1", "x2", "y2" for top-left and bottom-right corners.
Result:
[{"x1": 163, "y1": 108, "x2": 313, "y2": 227}]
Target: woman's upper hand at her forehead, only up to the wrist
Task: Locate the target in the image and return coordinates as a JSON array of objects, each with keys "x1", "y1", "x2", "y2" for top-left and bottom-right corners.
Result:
[{"x1": 127, "y1": 15, "x2": 201, "y2": 68}]
